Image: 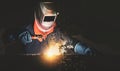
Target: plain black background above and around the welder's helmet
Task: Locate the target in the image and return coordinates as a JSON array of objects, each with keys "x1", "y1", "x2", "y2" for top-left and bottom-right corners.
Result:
[{"x1": 0, "y1": 0, "x2": 120, "y2": 48}]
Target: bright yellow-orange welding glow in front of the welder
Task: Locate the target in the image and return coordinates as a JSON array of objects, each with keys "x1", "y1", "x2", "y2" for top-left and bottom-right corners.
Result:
[{"x1": 40, "y1": 40, "x2": 68, "y2": 66}]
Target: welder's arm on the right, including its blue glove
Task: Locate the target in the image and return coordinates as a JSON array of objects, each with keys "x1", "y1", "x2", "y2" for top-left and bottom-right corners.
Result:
[{"x1": 47, "y1": 30, "x2": 95, "y2": 56}]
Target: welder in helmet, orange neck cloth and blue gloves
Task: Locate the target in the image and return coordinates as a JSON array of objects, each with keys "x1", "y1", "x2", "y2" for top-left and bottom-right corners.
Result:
[{"x1": 4, "y1": 2, "x2": 93, "y2": 55}]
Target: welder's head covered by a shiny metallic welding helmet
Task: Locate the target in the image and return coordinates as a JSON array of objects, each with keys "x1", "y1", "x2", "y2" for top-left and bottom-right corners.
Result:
[{"x1": 34, "y1": 2, "x2": 58, "y2": 29}]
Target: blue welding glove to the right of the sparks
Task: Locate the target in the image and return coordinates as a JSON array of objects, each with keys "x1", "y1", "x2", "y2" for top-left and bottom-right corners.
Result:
[{"x1": 74, "y1": 42, "x2": 94, "y2": 56}]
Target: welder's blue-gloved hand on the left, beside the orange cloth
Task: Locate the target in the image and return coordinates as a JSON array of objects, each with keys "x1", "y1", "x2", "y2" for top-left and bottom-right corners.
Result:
[{"x1": 19, "y1": 31, "x2": 32, "y2": 44}]
